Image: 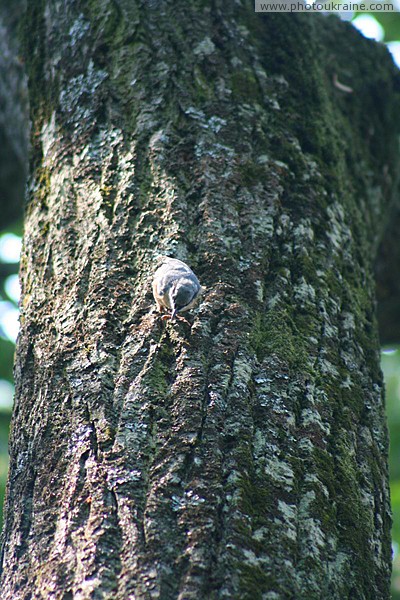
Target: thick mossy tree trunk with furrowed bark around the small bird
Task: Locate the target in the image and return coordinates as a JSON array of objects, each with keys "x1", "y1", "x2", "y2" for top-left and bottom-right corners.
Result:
[{"x1": 2, "y1": 0, "x2": 399, "y2": 600}]
